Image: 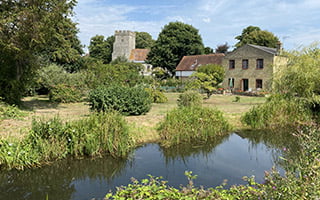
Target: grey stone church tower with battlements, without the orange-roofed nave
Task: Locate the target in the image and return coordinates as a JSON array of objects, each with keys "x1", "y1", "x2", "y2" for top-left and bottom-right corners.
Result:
[{"x1": 112, "y1": 31, "x2": 136, "y2": 60}]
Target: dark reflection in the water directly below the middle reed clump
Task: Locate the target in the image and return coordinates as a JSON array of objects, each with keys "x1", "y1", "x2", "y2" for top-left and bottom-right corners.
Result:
[{"x1": 160, "y1": 135, "x2": 230, "y2": 164}]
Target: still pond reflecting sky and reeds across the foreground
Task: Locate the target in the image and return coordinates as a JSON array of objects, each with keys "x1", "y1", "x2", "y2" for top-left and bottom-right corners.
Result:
[{"x1": 0, "y1": 132, "x2": 296, "y2": 200}]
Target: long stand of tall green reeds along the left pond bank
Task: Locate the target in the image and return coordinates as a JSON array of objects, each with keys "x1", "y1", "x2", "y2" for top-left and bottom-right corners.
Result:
[{"x1": 0, "y1": 112, "x2": 134, "y2": 169}]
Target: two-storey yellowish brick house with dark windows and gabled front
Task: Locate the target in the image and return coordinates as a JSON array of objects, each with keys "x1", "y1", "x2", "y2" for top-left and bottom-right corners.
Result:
[{"x1": 222, "y1": 44, "x2": 287, "y2": 91}]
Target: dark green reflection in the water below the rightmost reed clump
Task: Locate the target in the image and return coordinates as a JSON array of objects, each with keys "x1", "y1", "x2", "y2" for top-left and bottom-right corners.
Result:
[{"x1": 237, "y1": 130, "x2": 301, "y2": 169}]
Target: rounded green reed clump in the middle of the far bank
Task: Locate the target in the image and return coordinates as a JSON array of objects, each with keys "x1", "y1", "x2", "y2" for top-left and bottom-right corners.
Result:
[{"x1": 158, "y1": 106, "x2": 230, "y2": 146}]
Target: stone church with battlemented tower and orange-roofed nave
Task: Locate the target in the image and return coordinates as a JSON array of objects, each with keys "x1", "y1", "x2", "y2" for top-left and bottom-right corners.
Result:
[{"x1": 112, "y1": 30, "x2": 152, "y2": 76}]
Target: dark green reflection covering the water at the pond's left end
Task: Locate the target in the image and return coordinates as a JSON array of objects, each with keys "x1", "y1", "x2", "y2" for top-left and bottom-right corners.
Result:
[{"x1": 0, "y1": 157, "x2": 127, "y2": 200}]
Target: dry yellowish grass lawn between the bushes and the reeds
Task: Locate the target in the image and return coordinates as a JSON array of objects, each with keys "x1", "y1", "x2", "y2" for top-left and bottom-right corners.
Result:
[{"x1": 0, "y1": 93, "x2": 266, "y2": 143}]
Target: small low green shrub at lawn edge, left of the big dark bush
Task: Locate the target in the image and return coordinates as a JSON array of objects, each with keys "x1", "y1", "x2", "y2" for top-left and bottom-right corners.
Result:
[{"x1": 49, "y1": 84, "x2": 82, "y2": 103}]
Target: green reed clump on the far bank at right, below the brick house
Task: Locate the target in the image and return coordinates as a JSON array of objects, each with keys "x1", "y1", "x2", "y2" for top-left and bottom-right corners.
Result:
[{"x1": 241, "y1": 96, "x2": 311, "y2": 129}]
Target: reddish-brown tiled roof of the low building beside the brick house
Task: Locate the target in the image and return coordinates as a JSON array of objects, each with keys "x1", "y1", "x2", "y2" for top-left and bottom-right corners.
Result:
[{"x1": 176, "y1": 53, "x2": 224, "y2": 71}]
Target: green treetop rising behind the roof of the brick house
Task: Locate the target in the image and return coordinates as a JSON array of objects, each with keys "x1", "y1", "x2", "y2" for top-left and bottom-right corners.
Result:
[{"x1": 235, "y1": 26, "x2": 280, "y2": 48}]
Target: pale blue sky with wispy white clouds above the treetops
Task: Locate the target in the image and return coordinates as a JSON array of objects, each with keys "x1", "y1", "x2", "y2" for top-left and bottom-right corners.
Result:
[{"x1": 74, "y1": 0, "x2": 320, "y2": 50}]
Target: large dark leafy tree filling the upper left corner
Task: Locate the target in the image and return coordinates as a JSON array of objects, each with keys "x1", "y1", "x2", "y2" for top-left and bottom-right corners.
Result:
[{"x1": 0, "y1": 0, "x2": 76, "y2": 103}]
